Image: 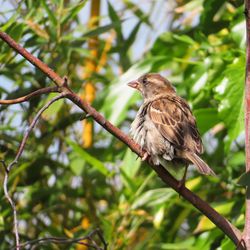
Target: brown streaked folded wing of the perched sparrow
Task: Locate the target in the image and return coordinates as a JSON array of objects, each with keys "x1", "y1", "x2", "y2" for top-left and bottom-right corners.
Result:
[{"x1": 149, "y1": 96, "x2": 203, "y2": 154}]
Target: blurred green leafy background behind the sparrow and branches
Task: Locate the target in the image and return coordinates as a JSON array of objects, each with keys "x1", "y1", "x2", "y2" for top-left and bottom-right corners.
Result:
[{"x1": 0, "y1": 0, "x2": 245, "y2": 249}]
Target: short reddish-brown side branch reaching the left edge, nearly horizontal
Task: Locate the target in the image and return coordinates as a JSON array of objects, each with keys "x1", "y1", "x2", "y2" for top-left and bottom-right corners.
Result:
[{"x1": 0, "y1": 87, "x2": 59, "y2": 105}]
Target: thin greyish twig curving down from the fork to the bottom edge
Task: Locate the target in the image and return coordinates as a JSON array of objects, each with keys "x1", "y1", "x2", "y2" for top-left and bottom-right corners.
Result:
[{"x1": 1, "y1": 93, "x2": 65, "y2": 250}]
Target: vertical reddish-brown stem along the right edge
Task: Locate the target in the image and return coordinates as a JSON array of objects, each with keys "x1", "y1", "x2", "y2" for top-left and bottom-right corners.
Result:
[{"x1": 243, "y1": 0, "x2": 250, "y2": 249}]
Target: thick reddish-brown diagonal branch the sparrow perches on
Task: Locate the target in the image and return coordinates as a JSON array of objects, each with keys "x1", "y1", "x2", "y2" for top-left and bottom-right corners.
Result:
[{"x1": 0, "y1": 32, "x2": 244, "y2": 248}]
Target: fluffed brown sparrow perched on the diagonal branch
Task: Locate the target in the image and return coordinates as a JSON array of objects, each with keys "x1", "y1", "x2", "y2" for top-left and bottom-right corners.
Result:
[{"x1": 128, "y1": 73, "x2": 215, "y2": 184}]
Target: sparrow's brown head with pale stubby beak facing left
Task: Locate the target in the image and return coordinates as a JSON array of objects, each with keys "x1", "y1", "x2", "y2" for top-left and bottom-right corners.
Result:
[{"x1": 128, "y1": 73, "x2": 175, "y2": 100}]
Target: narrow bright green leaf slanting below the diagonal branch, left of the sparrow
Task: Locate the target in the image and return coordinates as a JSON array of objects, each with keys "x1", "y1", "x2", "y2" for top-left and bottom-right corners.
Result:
[{"x1": 66, "y1": 139, "x2": 111, "y2": 176}]
